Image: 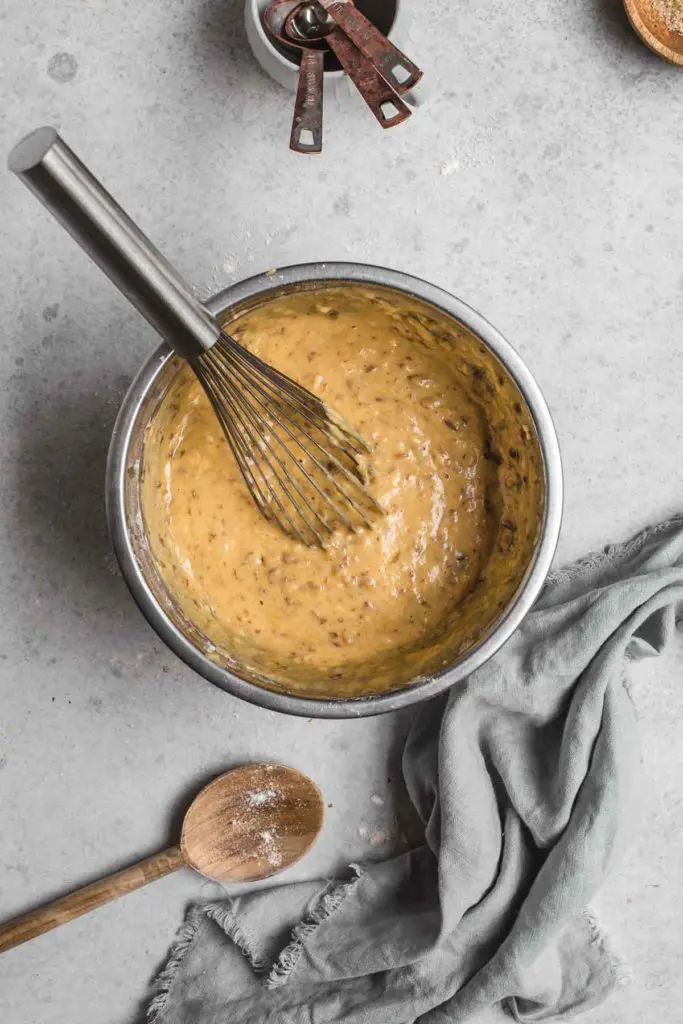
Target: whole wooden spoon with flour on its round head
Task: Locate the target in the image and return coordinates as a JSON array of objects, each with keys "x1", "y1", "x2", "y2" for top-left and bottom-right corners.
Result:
[{"x1": 0, "y1": 765, "x2": 323, "y2": 952}]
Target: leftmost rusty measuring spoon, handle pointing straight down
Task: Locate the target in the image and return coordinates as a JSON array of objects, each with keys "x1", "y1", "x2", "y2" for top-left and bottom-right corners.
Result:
[{"x1": 263, "y1": 0, "x2": 327, "y2": 153}]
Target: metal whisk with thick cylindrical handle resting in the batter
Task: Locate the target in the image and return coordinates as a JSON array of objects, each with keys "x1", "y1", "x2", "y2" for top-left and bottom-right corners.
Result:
[{"x1": 8, "y1": 128, "x2": 381, "y2": 545}]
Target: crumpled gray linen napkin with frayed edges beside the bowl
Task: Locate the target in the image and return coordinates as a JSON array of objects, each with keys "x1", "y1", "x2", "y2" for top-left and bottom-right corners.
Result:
[{"x1": 150, "y1": 515, "x2": 683, "y2": 1024}]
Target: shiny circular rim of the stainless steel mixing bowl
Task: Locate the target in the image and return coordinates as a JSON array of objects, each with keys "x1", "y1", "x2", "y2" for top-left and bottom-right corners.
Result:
[{"x1": 106, "y1": 263, "x2": 563, "y2": 718}]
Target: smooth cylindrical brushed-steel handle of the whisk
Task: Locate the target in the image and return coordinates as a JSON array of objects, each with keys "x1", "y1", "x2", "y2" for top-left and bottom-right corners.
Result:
[{"x1": 8, "y1": 128, "x2": 220, "y2": 357}]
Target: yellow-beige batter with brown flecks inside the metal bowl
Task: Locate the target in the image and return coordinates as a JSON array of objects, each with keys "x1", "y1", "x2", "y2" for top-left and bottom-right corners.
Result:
[{"x1": 143, "y1": 288, "x2": 544, "y2": 695}]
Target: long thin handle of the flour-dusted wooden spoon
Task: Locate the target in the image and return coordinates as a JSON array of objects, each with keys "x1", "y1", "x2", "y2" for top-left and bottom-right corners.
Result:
[{"x1": 0, "y1": 846, "x2": 185, "y2": 952}]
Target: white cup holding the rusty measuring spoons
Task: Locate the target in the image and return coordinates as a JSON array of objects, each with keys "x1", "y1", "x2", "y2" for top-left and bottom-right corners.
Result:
[{"x1": 245, "y1": 0, "x2": 426, "y2": 106}]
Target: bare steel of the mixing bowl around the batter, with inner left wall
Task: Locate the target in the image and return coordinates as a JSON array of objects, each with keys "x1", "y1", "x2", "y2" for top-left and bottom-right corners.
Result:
[{"x1": 106, "y1": 263, "x2": 562, "y2": 718}]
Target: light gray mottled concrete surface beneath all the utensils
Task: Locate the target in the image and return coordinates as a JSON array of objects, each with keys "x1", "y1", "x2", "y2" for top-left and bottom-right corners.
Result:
[{"x1": 0, "y1": 0, "x2": 683, "y2": 1024}]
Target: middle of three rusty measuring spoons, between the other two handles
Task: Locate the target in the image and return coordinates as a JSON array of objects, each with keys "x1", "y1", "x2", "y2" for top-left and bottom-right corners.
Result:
[{"x1": 283, "y1": 0, "x2": 411, "y2": 128}]
